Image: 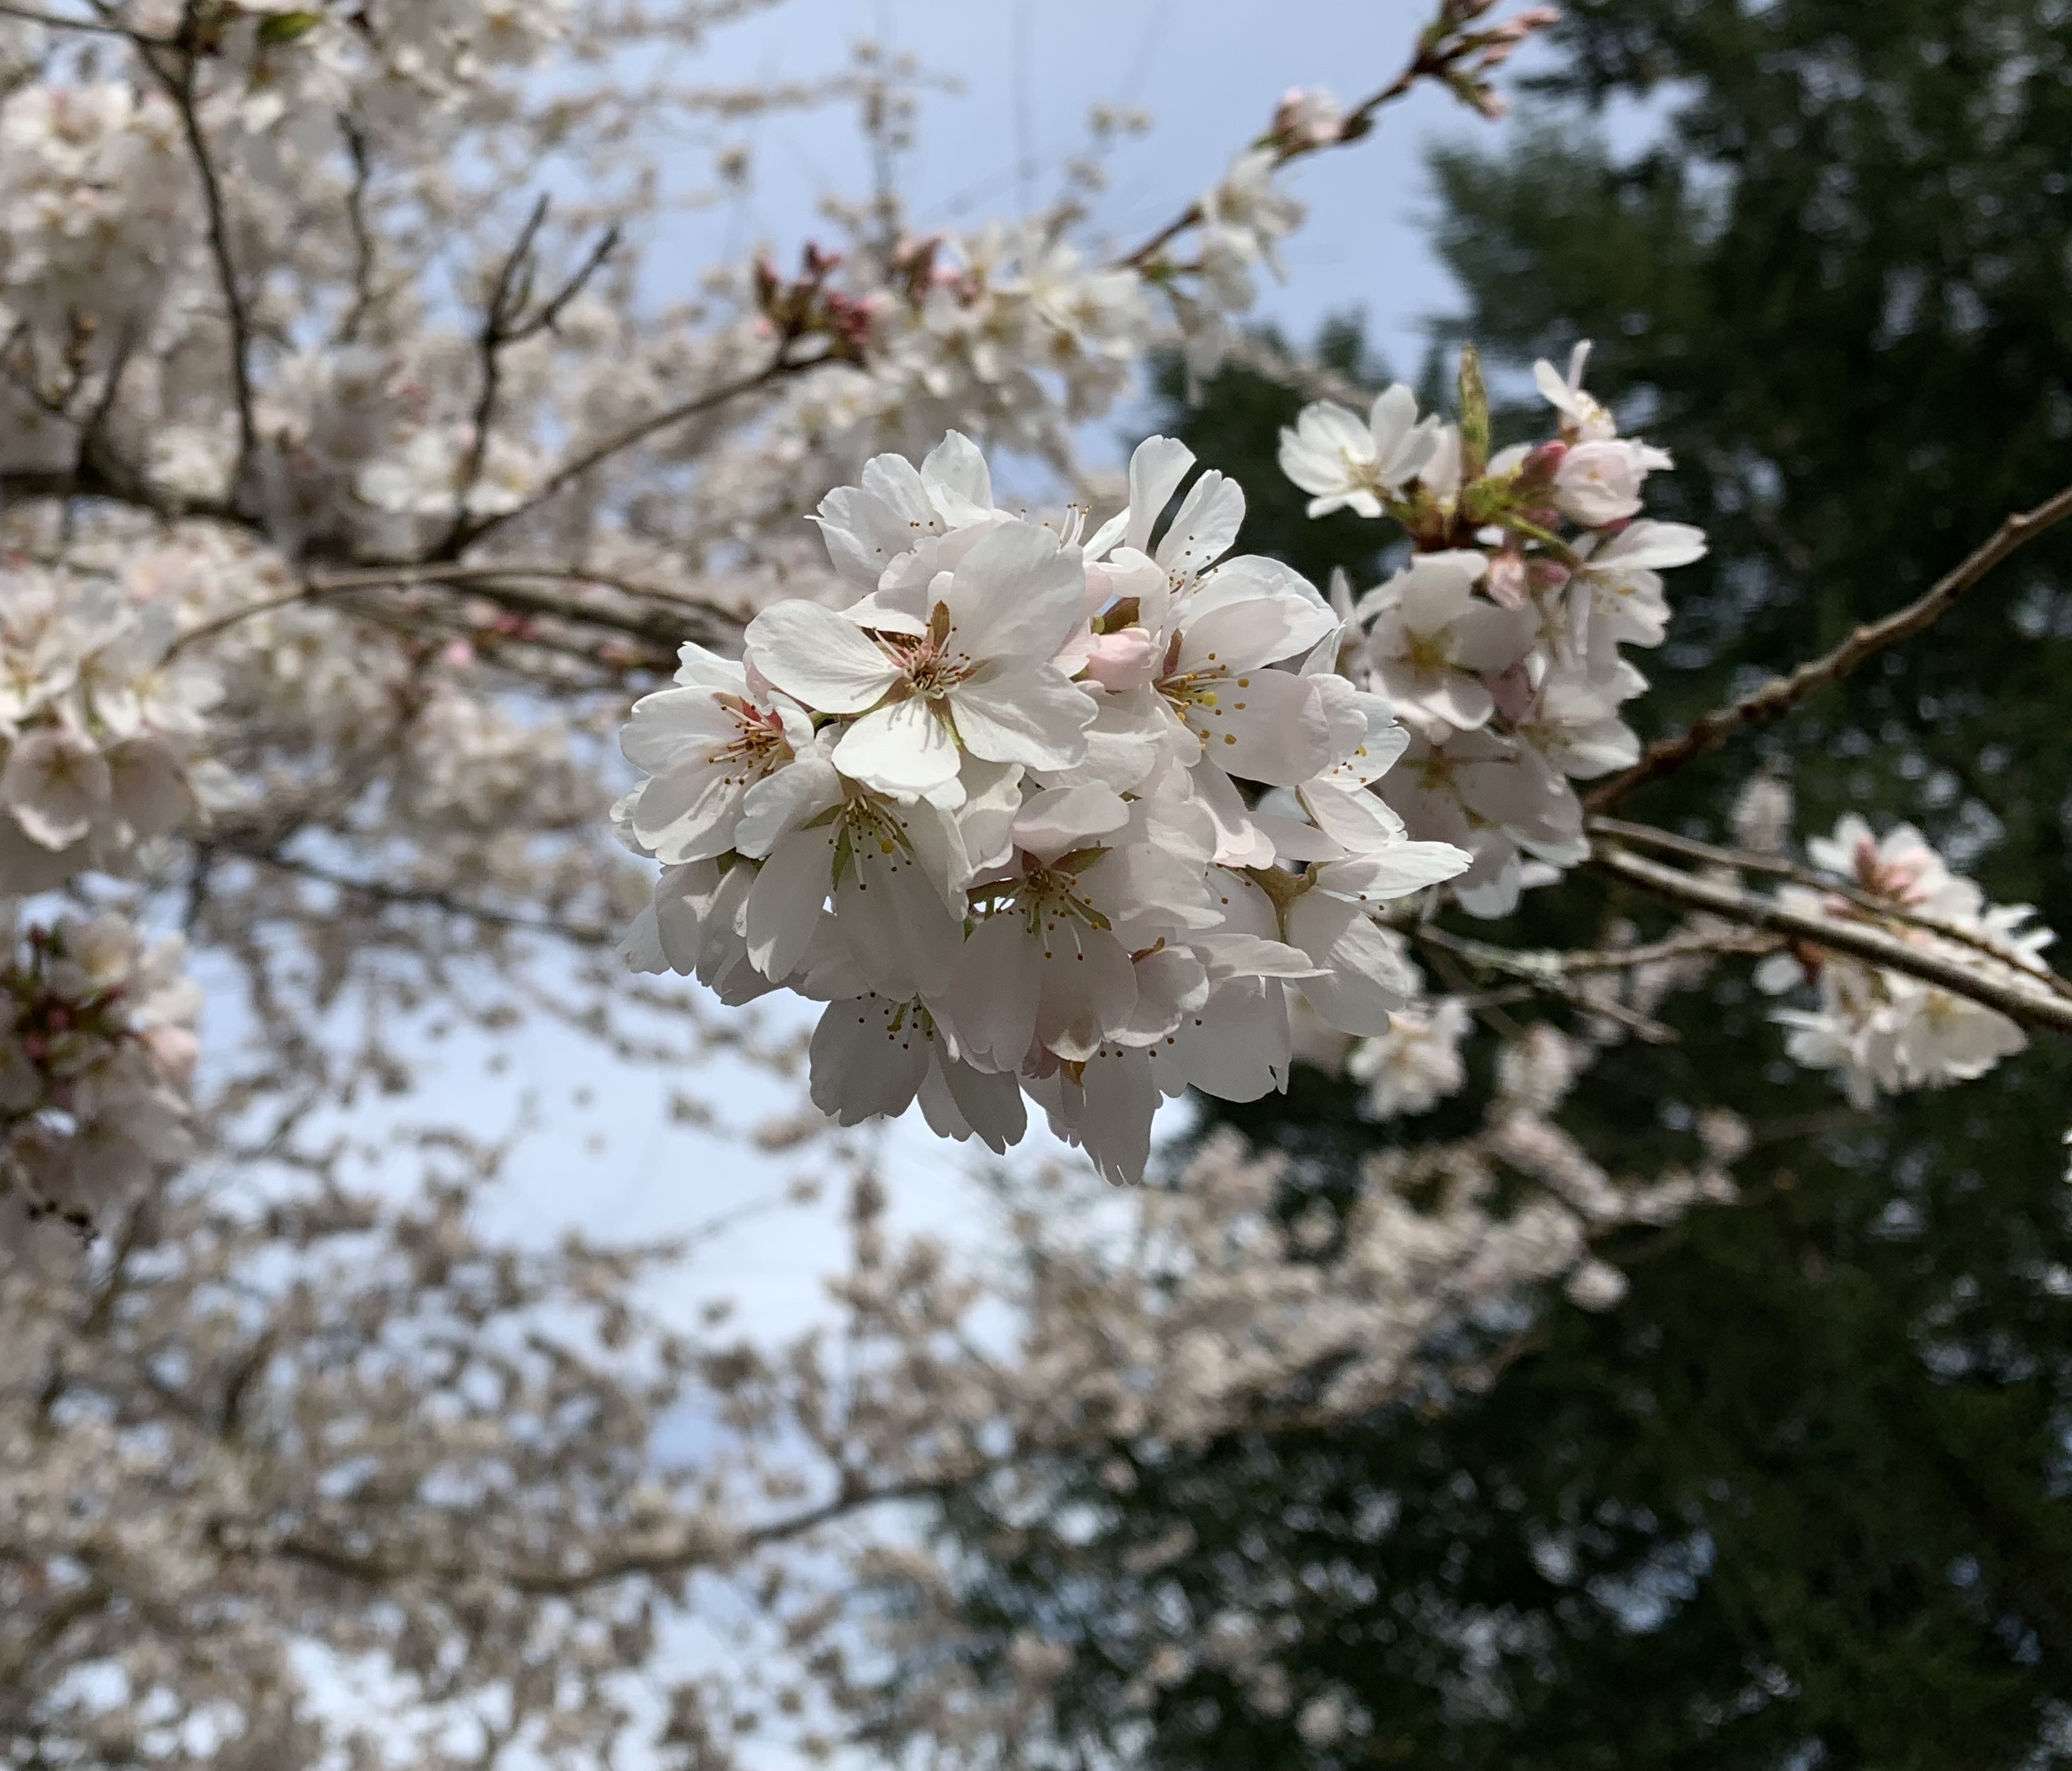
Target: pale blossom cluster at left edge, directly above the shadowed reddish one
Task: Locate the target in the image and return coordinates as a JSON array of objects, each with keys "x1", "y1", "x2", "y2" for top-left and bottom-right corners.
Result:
[{"x1": 0, "y1": 571, "x2": 218, "y2": 893}]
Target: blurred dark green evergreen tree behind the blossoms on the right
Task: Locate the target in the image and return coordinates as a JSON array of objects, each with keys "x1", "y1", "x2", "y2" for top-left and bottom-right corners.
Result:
[{"x1": 947, "y1": 0, "x2": 2072, "y2": 1771}]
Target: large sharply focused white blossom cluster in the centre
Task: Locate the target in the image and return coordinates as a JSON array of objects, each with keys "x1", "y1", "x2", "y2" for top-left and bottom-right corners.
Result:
[{"x1": 618, "y1": 433, "x2": 1469, "y2": 1178}]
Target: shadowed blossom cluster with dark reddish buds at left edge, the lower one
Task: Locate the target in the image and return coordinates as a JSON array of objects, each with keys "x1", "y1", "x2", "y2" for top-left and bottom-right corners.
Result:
[{"x1": 0, "y1": 913, "x2": 201, "y2": 1230}]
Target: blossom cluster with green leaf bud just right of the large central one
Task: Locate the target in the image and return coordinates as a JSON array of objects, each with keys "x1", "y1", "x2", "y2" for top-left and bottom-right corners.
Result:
[{"x1": 1280, "y1": 344, "x2": 1705, "y2": 916}]
